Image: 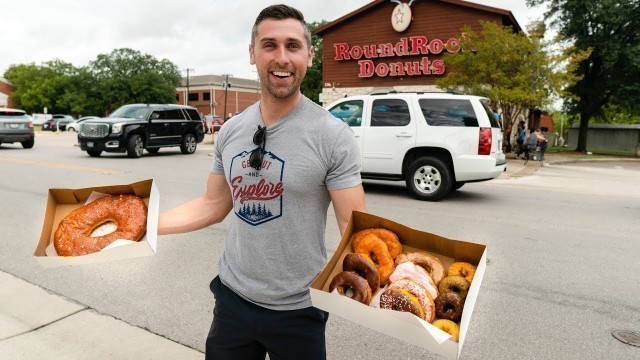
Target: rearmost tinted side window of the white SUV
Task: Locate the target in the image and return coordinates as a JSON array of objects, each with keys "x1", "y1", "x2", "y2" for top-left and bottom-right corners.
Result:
[{"x1": 418, "y1": 99, "x2": 479, "y2": 127}]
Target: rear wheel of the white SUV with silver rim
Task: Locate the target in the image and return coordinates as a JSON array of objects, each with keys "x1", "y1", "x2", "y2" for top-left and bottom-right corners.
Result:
[{"x1": 405, "y1": 156, "x2": 452, "y2": 201}]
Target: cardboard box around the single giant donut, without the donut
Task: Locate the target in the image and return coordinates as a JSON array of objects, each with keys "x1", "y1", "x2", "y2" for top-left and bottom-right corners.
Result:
[{"x1": 33, "y1": 179, "x2": 160, "y2": 268}]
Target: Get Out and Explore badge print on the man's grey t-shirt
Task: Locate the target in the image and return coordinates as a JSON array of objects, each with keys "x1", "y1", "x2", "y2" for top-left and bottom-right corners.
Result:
[{"x1": 229, "y1": 149, "x2": 284, "y2": 226}]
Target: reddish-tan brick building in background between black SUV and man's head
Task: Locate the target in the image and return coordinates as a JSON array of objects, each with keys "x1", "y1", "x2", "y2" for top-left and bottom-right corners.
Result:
[{"x1": 176, "y1": 75, "x2": 260, "y2": 119}]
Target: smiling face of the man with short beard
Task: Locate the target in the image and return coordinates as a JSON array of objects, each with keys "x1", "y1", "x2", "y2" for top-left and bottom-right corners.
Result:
[{"x1": 249, "y1": 19, "x2": 313, "y2": 99}]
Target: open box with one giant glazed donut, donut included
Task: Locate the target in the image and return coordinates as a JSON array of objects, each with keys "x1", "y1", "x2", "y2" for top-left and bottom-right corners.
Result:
[{"x1": 33, "y1": 179, "x2": 160, "y2": 268}]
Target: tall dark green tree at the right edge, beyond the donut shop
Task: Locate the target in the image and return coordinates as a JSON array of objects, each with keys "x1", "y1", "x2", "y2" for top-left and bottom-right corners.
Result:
[{"x1": 527, "y1": 0, "x2": 640, "y2": 152}]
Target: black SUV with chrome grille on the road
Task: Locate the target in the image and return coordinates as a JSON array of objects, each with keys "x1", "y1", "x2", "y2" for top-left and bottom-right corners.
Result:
[{"x1": 78, "y1": 104, "x2": 204, "y2": 158}]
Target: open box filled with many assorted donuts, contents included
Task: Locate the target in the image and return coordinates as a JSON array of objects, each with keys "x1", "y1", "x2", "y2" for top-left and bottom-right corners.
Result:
[{"x1": 310, "y1": 211, "x2": 487, "y2": 359}]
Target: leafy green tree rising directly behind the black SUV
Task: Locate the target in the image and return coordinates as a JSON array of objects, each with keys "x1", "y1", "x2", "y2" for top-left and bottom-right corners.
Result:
[{"x1": 89, "y1": 48, "x2": 180, "y2": 112}]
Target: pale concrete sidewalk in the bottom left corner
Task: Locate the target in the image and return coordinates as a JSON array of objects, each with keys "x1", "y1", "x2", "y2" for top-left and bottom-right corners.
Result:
[{"x1": 0, "y1": 271, "x2": 204, "y2": 360}]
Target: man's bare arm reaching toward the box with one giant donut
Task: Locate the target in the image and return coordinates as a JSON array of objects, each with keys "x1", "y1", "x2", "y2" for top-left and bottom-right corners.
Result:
[{"x1": 158, "y1": 174, "x2": 233, "y2": 235}]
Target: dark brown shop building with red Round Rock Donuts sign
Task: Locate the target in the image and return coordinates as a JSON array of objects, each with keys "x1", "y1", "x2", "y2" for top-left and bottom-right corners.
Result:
[{"x1": 314, "y1": 0, "x2": 521, "y2": 105}]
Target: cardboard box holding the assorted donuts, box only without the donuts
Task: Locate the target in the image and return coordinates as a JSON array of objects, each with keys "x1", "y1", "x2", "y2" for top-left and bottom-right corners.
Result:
[{"x1": 310, "y1": 211, "x2": 487, "y2": 359}]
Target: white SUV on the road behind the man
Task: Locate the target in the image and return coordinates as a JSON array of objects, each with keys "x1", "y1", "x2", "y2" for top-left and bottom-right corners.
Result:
[{"x1": 327, "y1": 92, "x2": 507, "y2": 201}]
